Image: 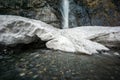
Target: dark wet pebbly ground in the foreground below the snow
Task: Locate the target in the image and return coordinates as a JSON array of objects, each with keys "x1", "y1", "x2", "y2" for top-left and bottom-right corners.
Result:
[{"x1": 0, "y1": 49, "x2": 120, "y2": 80}]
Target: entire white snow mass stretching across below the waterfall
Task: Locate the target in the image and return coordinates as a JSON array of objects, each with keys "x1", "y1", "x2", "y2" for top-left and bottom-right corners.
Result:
[{"x1": 0, "y1": 15, "x2": 120, "y2": 54}]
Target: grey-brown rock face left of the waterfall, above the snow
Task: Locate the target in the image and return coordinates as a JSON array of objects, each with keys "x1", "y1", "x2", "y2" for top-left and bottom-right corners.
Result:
[{"x1": 0, "y1": 0, "x2": 60, "y2": 27}]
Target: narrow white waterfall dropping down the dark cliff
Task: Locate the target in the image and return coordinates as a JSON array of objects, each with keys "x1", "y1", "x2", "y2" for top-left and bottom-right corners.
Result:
[{"x1": 60, "y1": 0, "x2": 69, "y2": 29}]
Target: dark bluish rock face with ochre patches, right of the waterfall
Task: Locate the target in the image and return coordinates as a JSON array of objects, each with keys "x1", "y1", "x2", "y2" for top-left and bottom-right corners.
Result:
[{"x1": 70, "y1": 0, "x2": 120, "y2": 26}]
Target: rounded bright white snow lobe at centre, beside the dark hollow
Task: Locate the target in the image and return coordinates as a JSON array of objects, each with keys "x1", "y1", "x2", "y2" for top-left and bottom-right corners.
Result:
[{"x1": 46, "y1": 36, "x2": 76, "y2": 52}]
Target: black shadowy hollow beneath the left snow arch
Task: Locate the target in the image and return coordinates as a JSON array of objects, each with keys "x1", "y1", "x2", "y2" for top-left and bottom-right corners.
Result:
[{"x1": 0, "y1": 38, "x2": 47, "y2": 54}]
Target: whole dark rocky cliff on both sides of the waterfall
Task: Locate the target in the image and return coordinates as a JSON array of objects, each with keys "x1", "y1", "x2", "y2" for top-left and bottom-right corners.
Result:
[{"x1": 0, "y1": 0, "x2": 120, "y2": 27}]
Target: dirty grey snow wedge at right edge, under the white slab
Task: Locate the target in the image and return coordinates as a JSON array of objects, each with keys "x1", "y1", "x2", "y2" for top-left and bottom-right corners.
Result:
[{"x1": 92, "y1": 31, "x2": 120, "y2": 48}]
